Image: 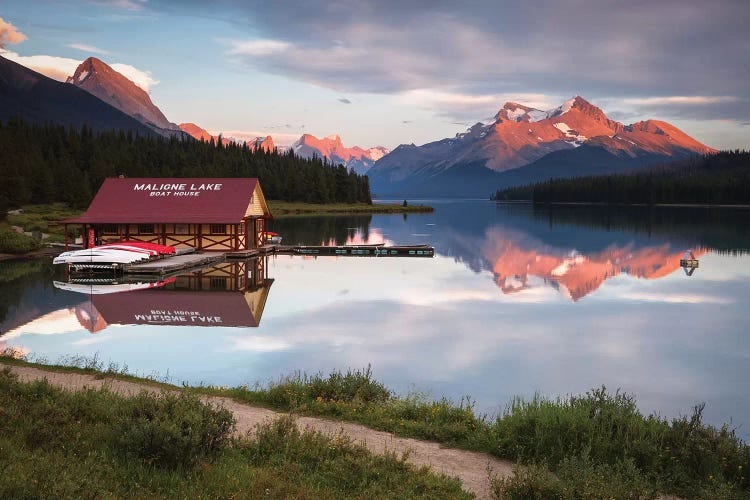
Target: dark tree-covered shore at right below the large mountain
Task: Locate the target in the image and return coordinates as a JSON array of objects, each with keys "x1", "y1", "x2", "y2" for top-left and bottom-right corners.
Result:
[{"x1": 491, "y1": 149, "x2": 750, "y2": 205}]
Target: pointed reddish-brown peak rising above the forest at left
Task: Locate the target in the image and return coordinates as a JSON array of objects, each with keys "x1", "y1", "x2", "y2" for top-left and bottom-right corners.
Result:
[{"x1": 66, "y1": 57, "x2": 182, "y2": 136}]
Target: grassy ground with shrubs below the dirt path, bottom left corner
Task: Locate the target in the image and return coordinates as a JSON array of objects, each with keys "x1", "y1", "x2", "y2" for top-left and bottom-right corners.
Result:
[{"x1": 0, "y1": 369, "x2": 470, "y2": 498}]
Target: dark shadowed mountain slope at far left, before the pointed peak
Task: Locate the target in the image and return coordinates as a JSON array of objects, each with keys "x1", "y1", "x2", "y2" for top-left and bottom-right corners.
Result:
[{"x1": 0, "y1": 56, "x2": 155, "y2": 136}]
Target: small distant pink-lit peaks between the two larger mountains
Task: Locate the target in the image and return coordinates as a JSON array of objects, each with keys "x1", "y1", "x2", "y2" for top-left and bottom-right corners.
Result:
[{"x1": 292, "y1": 134, "x2": 389, "y2": 174}]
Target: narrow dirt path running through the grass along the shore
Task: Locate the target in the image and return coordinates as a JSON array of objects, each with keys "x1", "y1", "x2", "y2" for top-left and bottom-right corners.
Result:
[{"x1": 0, "y1": 363, "x2": 512, "y2": 499}]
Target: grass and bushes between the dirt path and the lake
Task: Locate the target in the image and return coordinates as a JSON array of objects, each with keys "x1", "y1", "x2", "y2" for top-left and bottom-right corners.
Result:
[{"x1": 2, "y1": 354, "x2": 750, "y2": 498}]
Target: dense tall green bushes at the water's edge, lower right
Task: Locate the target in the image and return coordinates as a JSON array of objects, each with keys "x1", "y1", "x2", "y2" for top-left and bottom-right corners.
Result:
[{"x1": 490, "y1": 387, "x2": 750, "y2": 494}]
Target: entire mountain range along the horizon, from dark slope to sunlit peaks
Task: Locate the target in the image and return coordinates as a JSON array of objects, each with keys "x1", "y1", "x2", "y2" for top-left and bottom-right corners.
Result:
[{"x1": 0, "y1": 56, "x2": 715, "y2": 197}]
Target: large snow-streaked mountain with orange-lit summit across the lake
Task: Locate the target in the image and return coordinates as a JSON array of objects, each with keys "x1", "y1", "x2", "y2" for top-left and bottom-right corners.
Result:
[{"x1": 368, "y1": 96, "x2": 713, "y2": 195}]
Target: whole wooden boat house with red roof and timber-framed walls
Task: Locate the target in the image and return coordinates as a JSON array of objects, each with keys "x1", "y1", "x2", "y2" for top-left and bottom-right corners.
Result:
[{"x1": 62, "y1": 178, "x2": 271, "y2": 251}]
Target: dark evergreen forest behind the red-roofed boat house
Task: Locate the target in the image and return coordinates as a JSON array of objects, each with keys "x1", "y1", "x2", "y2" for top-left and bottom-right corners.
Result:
[{"x1": 0, "y1": 118, "x2": 372, "y2": 210}]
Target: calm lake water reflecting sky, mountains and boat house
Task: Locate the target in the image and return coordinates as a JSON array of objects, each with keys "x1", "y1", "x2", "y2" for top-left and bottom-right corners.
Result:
[{"x1": 0, "y1": 201, "x2": 750, "y2": 440}]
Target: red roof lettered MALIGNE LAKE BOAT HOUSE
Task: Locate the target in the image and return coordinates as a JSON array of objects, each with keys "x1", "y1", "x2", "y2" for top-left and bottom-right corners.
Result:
[{"x1": 63, "y1": 177, "x2": 258, "y2": 224}]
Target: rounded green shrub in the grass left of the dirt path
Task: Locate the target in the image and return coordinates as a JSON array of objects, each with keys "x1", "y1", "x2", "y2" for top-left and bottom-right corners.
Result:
[{"x1": 116, "y1": 392, "x2": 235, "y2": 468}]
